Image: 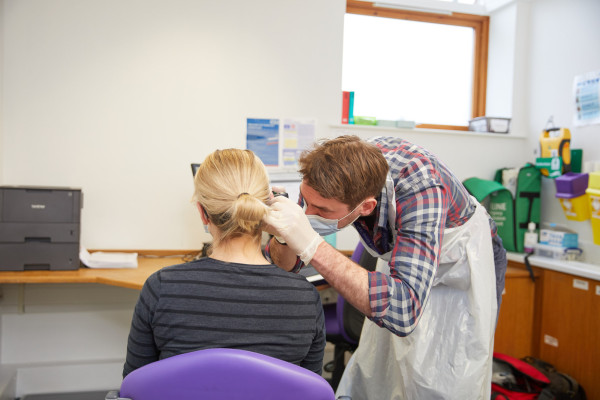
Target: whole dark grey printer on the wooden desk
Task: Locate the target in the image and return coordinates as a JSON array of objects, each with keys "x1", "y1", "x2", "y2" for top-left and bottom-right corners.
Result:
[{"x1": 0, "y1": 186, "x2": 83, "y2": 271}]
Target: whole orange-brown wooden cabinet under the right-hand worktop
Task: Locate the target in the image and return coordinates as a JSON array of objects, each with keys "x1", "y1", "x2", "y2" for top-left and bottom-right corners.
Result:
[{"x1": 494, "y1": 261, "x2": 600, "y2": 399}]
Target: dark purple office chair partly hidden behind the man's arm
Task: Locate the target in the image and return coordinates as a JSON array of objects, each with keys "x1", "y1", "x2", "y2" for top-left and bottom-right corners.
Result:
[{"x1": 323, "y1": 242, "x2": 377, "y2": 390}]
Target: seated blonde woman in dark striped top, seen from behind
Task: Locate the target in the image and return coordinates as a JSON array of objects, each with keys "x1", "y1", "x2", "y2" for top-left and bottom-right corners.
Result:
[{"x1": 123, "y1": 149, "x2": 325, "y2": 377}]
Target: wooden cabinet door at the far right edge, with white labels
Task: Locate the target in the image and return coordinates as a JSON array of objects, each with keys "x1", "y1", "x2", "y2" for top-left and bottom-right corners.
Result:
[{"x1": 540, "y1": 270, "x2": 600, "y2": 399}]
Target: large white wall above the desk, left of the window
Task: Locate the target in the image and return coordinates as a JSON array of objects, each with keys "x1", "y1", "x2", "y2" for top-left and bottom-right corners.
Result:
[{"x1": 1, "y1": 0, "x2": 345, "y2": 249}]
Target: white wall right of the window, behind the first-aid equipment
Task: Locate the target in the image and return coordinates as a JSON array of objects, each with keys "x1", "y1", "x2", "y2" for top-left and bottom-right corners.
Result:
[{"x1": 522, "y1": 0, "x2": 600, "y2": 256}]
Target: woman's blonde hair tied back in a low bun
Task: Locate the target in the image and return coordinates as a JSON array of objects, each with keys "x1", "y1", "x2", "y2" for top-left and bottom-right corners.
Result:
[{"x1": 194, "y1": 149, "x2": 269, "y2": 246}]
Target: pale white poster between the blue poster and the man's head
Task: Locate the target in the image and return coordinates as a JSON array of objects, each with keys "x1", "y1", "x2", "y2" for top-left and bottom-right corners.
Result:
[{"x1": 281, "y1": 118, "x2": 315, "y2": 168}]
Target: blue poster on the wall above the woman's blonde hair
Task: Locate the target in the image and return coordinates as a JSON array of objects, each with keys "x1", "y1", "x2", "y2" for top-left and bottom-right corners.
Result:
[{"x1": 246, "y1": 118, "x2": 279, "y2": 167}]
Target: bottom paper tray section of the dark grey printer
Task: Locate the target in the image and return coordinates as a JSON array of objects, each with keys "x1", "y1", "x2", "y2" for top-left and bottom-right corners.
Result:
[{"x1": 0, "y1": 242, "x2": 79, "y2": 271}]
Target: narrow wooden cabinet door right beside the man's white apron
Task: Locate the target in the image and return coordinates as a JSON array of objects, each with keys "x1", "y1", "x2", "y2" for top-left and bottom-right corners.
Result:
[{"x1": 494, "y1": 263, "x2": 535, "y2": 358}]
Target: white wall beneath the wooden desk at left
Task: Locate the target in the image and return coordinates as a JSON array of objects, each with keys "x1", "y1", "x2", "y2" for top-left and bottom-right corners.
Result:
[{"x1": 0, "y1": 284, "x2": 139, "y2": 398}]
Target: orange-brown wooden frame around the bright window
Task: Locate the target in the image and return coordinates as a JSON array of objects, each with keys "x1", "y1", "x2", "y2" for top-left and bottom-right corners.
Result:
[{"x1": 346, "y1": 0, "x2": 490, "y2": 131}]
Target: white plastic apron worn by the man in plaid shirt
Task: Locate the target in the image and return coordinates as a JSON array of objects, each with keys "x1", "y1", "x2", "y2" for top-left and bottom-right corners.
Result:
[{"x1": 336, "y1": 192, "x2": 497, "y2": 400}]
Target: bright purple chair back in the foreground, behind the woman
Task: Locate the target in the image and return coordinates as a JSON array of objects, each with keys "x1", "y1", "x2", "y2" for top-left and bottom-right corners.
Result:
[{"x1": 106, "y1": 348, "x2": 335, "y2": 400}]
